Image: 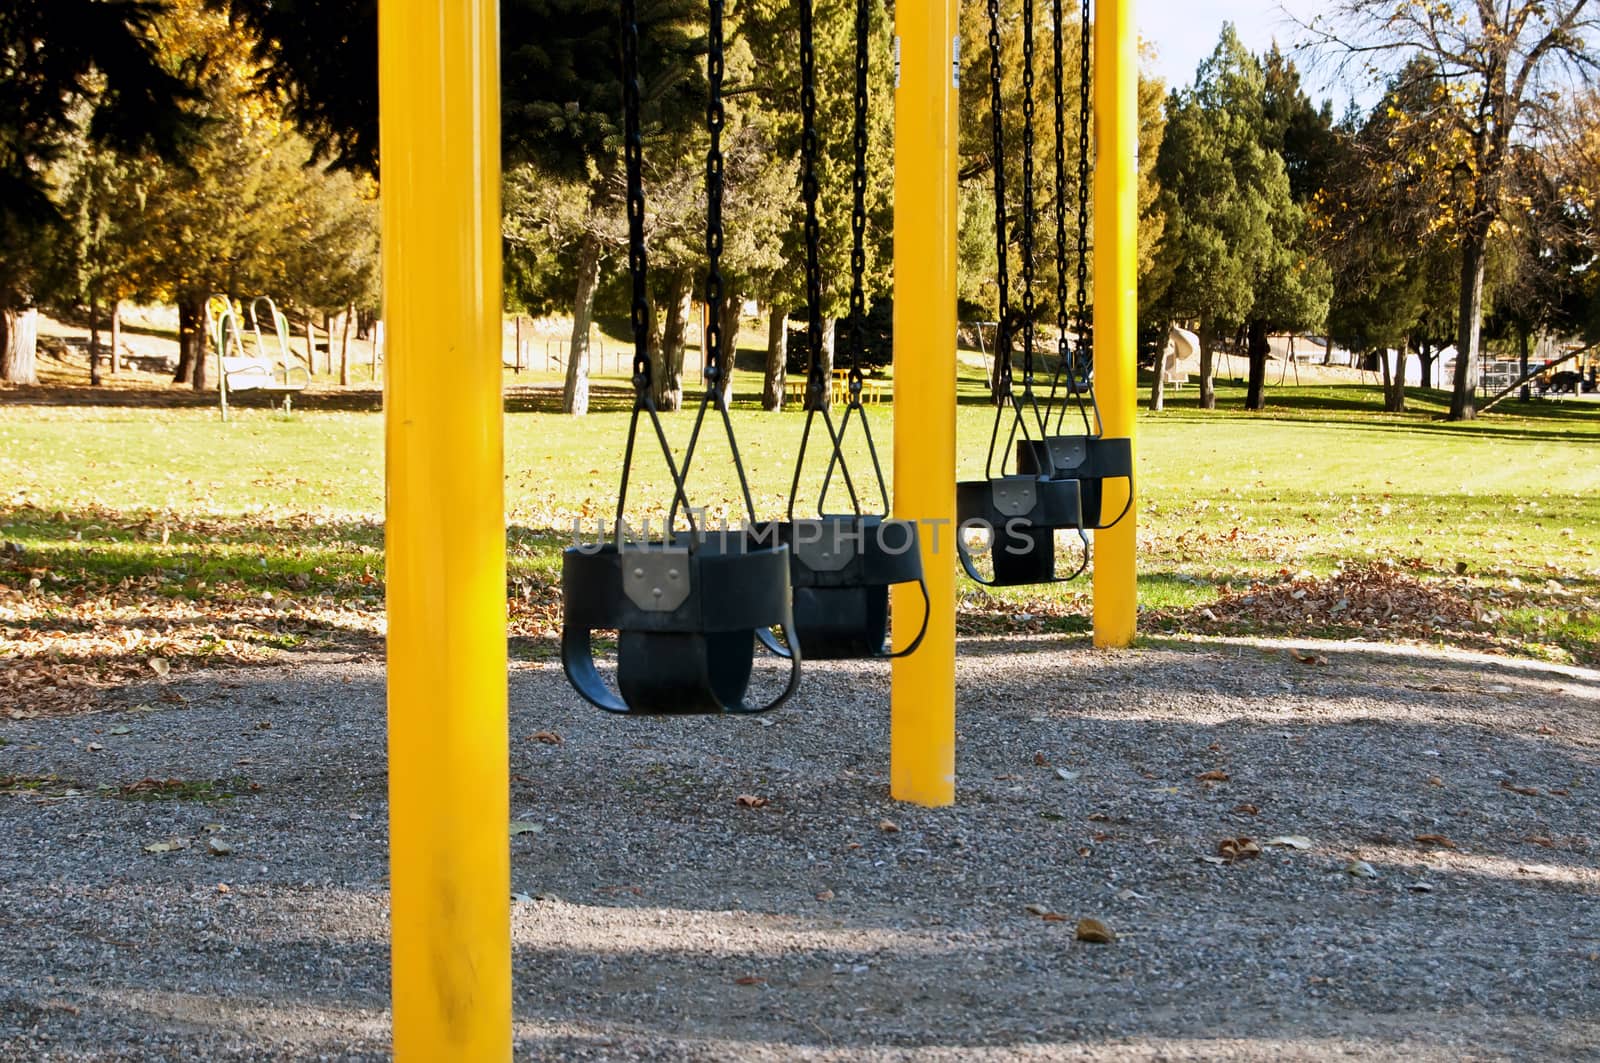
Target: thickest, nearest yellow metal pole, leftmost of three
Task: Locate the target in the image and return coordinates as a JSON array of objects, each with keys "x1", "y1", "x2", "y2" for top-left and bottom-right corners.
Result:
[{"x1": 378, "y1": 0, "x2": 510, "y2": 1060}]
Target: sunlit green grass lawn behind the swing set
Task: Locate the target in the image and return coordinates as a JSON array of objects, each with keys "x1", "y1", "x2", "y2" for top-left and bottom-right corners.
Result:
[{"x1": 0, "y1": 375, "x2": 1600, "y2": 697}]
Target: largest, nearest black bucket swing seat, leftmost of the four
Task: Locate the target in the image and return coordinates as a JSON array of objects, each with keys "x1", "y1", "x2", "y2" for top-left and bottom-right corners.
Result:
[{"x1": 562, "y1": 532, "x2": 800, "y2": 716}]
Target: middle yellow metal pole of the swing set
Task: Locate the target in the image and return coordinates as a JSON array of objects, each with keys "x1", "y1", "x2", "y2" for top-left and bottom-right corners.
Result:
[{"x1": 890, "y1": 0, "x2": 958, "y2": 805}]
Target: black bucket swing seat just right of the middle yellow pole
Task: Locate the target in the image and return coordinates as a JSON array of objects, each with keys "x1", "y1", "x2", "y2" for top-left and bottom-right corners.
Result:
[{"x1": 955, "y1": 472, "x2": 1083, "y2": 588}]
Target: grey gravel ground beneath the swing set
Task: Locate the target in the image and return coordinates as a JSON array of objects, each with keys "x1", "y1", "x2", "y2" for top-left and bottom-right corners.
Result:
[{"x1": 0, "y1": 639, "x2": 1600, "y2": 1060}]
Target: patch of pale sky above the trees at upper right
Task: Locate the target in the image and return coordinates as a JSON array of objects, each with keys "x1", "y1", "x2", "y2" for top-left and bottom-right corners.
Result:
[{"x1": 1134, "y1": 0, "x2": 1352, "y2": 112}]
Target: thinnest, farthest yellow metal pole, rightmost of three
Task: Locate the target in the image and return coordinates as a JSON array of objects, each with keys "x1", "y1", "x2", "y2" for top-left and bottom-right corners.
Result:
[{"x1": 1094, "y1": 0, "x2": 1139, "y2": 647}]
